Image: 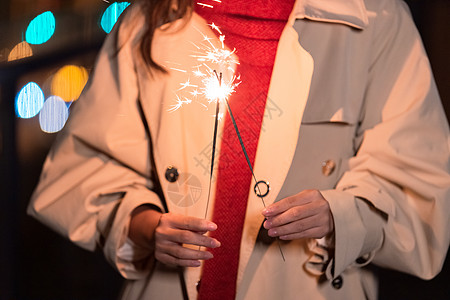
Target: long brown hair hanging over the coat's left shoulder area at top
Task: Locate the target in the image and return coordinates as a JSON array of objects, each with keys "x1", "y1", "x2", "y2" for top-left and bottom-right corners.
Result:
[{"x1": 140, "y1": 0, "x2": 193, "y2": 73}]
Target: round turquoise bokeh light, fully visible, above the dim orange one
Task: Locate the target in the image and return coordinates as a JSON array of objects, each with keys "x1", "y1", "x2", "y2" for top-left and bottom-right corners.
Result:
[{"x1": 25, "y1": 11, "x2": 56, "y2": 45}]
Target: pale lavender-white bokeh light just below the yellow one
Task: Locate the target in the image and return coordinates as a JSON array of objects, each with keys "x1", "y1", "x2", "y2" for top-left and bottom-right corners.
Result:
[{"x1": 39, "y1": 96, "x2": 69, "y2": 133}]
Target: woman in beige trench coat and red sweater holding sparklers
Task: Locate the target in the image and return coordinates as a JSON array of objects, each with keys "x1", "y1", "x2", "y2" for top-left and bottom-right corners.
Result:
[{"x1": 29, "y1": 0, "x2": 450, "y2": 299}]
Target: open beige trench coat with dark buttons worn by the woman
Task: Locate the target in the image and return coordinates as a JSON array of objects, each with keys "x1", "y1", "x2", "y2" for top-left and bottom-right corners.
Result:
[{"x1": 28, "y1": 0, "x2": 450, "y2": 299}]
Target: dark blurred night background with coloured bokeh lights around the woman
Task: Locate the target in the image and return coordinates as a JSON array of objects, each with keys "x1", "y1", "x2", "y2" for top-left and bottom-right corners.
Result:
[{"x1": 0, "y1": 0, "x2": 450, "y2": 300}]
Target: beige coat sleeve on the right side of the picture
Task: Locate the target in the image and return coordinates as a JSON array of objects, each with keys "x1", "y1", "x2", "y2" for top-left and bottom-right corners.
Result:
[{"x1": 323, "y1": 1, "x2": 450, "y2": 279}]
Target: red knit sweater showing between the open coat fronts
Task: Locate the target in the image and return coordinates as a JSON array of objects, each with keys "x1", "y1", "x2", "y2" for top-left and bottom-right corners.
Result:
[{"x1": 196, "y1": 0, "x2": 295, "y2": 300}]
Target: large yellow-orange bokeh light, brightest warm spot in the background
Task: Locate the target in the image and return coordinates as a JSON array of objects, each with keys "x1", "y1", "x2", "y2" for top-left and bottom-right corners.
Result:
[{"x1": 51, "y1": 65, "x2": 89, "y2": 102}]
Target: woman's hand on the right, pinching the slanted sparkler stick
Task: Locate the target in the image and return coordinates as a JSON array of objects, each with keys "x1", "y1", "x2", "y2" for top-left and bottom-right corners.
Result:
[{"x1": 262, "y1": 190, "x2": 334, "y2": 240}]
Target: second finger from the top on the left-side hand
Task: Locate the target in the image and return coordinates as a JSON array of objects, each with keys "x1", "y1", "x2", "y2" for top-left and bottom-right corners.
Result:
[{"x1": 155, "y1": 227, "x2": 220, "y2": 248}]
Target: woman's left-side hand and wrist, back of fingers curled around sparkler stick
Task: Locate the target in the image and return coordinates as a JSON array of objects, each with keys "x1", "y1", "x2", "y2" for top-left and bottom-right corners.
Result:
[{"x1": 129, "y1": 208, "x2": 220, "y2": 267}]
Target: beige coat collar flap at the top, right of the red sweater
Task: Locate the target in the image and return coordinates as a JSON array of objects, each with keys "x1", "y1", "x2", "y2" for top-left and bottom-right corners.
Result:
[{"x1": 294, "y1": 0, "x2": 369, "y2": 29}]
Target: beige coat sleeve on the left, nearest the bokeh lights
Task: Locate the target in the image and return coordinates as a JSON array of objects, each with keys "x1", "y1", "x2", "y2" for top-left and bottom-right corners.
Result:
[{"x1": 28, "y1": 6, "x2": 162, "y2": 279}]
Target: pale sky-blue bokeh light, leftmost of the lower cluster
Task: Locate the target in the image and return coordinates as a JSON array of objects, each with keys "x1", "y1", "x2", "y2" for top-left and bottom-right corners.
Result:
[{"x1": 16, "y1": 82, "x2": 44, "y2": 119}]
